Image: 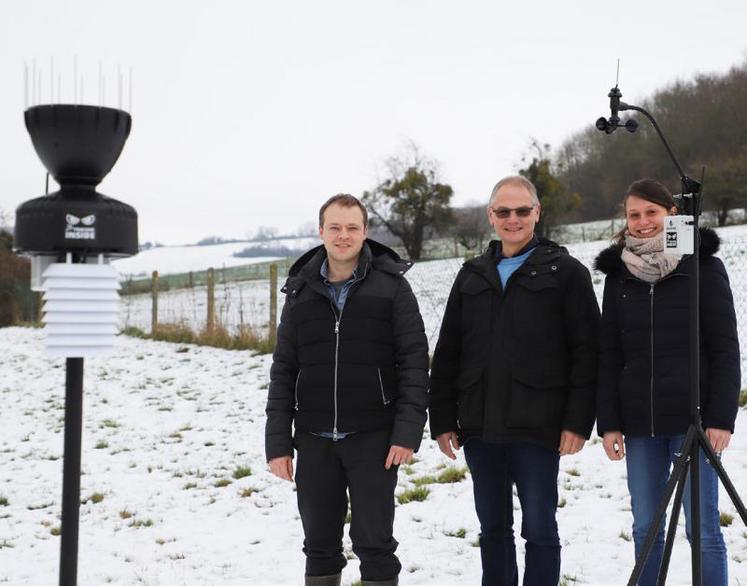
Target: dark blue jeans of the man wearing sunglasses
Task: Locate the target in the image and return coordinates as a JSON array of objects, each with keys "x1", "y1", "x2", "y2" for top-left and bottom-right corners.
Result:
[{"x1": 464, "y1": 438, "x2": 560, "y2": 586}]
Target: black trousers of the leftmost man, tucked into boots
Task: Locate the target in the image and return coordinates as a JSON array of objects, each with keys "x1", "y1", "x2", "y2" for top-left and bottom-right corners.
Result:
[{"x1": 295, "y1": 430, "x2": 402, "y2": 580}]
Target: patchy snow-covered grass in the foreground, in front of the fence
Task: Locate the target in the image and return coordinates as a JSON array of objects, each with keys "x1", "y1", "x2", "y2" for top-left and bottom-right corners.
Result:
[{"x1": 0, "y1": 328, "x2": 747, "y2": 586}]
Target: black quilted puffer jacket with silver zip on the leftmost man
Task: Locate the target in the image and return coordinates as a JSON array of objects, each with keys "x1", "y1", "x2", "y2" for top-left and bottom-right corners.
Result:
[{"x1": 265, "y1": 240, "x2": 428, "y2": 460}]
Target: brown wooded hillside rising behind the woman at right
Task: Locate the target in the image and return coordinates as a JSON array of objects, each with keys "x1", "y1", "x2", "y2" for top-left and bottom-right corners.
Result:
[{"x1": 553, "y1": 63, "x2": 747, "y2": 225}]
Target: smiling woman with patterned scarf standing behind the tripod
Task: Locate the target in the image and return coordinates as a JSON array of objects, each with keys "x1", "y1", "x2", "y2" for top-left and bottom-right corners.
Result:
[{"x1": 595, "y1": 179, "x2": 741, "y2": 586}]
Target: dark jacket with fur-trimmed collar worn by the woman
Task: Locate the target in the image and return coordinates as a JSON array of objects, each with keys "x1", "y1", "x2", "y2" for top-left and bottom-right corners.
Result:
[{"x1": 595, "y1": 229, "x2": 740, "y2": 436}]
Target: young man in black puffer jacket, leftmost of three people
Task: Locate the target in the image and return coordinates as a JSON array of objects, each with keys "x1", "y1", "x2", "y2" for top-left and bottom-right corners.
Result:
[{"x1": 265, "y1": 194, "x2": 428, "y2": 586}]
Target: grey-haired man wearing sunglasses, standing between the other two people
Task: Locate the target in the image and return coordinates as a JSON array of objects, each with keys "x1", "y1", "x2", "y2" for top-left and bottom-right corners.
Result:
[{"x1": 430, "y1": 176, "x2": 599, "y2": 586}]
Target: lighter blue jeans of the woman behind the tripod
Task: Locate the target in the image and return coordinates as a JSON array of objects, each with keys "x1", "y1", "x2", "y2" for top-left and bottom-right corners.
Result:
[{"x1": 625, "y1": 435, "x2": 728, "y2": 586}]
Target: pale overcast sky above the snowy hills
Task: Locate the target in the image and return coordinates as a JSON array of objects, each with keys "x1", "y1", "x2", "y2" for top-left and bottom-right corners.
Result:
[{"x1": 0, "y1": 0, "x2": 747, "y2": 244}]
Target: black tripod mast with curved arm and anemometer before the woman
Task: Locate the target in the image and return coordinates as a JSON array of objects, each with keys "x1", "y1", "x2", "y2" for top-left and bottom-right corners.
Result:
[{"x1": 596, "y1": 85, "x2": 747, "y2": 586}]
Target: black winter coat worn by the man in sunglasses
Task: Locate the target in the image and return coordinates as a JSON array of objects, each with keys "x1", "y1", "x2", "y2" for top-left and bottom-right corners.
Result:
[{"x1": 430, "y1": 239, "x2": 599, "y2": 449}]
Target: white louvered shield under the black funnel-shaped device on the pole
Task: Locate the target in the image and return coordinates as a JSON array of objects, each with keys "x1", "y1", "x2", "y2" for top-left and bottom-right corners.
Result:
[{"x1": 42, "y1": 263, "x2": 119, "y2": 358}]
